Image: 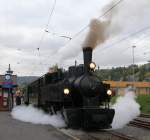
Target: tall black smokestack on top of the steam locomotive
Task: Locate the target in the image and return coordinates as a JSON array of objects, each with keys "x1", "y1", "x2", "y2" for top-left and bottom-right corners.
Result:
[{"x1": 83, "y1": 47, "x2": 92, "y2": 72}]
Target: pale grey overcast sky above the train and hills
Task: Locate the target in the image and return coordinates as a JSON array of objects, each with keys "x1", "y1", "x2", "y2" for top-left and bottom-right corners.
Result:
[{"x1": 0, "y1": 0, "x2": 150, "y2": 75}]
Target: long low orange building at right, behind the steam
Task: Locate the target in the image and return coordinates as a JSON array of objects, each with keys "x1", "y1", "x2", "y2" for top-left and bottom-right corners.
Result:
[{"x1": 104, "y1": 81, "x2": 150, "y2": 94}]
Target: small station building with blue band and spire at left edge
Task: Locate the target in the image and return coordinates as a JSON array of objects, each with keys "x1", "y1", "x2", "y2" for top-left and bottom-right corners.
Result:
[{"x1": 0, "y1": 64, "x2": 17, "y2": 110}]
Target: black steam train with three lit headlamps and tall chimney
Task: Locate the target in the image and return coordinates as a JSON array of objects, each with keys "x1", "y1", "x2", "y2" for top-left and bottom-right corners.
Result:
[{"x1": 26, "y1": 47, "x2": 115, "y2": 129}]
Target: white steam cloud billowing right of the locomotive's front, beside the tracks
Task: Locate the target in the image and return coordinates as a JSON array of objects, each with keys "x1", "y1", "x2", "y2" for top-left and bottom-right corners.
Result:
[{"x1": 112, "y1": 91, "x2": 140, "y2": 129}]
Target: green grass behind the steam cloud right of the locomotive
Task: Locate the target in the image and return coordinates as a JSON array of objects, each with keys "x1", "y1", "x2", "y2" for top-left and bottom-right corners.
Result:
[{"x1": 111, "y1": 94, "x2": 150, "y2": 114}]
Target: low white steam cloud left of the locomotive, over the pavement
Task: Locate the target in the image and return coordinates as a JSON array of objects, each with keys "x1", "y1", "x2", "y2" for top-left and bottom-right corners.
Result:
[{"x1": 11, "y1": 105, "x2": 66, "y2": 127}]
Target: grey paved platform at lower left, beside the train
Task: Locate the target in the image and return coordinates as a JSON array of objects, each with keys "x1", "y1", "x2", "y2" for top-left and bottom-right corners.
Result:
[{"x1": 0, "y1": 112, "x2": 71, "y2": 140}]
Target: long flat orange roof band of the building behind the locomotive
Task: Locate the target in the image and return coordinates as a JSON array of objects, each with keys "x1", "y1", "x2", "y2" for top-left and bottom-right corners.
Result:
[{"x1": 103, "y1": 81, "x2": 150, "y2": 88}]
